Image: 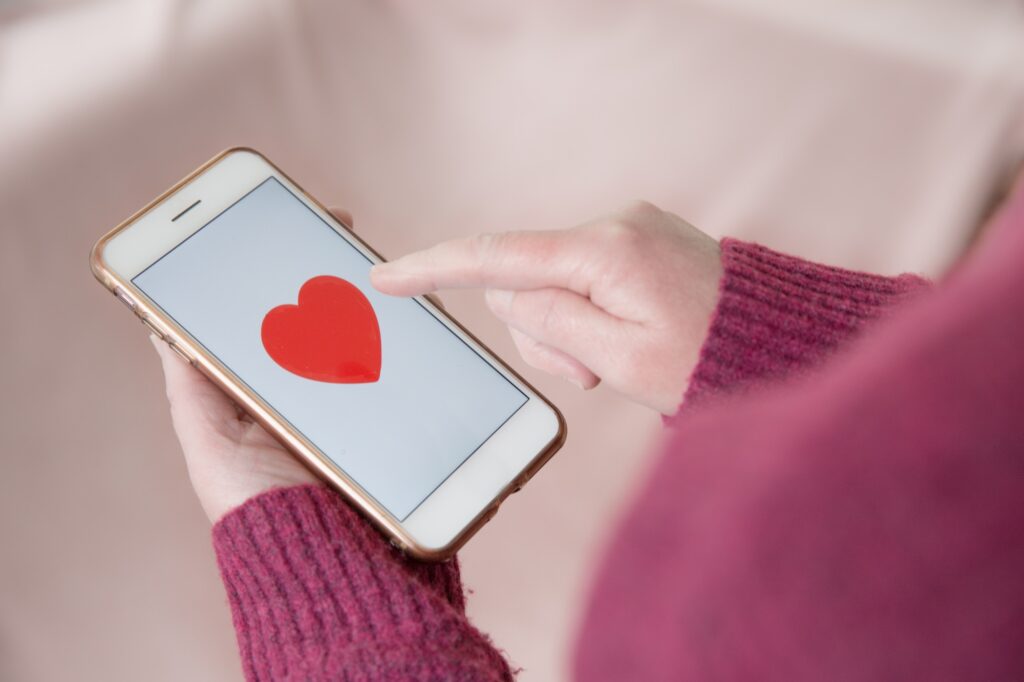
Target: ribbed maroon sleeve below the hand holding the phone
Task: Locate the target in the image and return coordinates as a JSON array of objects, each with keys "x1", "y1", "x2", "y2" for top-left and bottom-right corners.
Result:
[{"x1": 213, "y1": 485, "x2": 512, "y2": 680}]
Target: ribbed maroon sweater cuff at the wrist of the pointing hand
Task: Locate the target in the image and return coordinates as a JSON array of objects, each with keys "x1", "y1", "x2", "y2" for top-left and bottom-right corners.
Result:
[{"x1": 684, "y1": 239, "x2": 928, "y2": 406}]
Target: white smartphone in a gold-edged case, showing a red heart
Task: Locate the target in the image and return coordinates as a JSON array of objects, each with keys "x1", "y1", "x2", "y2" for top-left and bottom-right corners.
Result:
[{"x1": 90, "y1": 148, "x2": 565, "y2": 560}]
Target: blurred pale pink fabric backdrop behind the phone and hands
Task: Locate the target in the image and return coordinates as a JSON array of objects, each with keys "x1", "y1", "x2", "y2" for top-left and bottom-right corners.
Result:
[{"x1": 0, "y1": 0, "x2": 1024, "y2": 682}]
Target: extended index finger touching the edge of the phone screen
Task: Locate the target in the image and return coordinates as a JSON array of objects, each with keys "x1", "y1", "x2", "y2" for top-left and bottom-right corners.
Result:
[{"x1": 370, "y1": 229, "x2": 589, "y2": 296}]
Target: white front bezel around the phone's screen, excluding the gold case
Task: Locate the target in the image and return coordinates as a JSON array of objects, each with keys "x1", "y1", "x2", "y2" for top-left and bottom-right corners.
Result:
[{"x1": 102, "y1": 150, "x2": 563, "y2": 552}]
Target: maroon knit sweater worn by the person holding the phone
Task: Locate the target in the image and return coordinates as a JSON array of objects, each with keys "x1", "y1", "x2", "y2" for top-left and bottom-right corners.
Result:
[{"x1": 214, "y1": 188, "x2": 1024, "y2": 682}]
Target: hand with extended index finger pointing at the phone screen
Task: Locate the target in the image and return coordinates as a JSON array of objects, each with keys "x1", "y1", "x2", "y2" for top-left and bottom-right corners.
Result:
[{"x1": 372, "y1": 202, "x2": 722, "y2": 414}]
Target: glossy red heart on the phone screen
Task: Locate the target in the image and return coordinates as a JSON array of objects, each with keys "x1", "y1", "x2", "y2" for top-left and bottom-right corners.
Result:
[{"x1": 260, "y1": 274, "x2": 381, "y2": 384}]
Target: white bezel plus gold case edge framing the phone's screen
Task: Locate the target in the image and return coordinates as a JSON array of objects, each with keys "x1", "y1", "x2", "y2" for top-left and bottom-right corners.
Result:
[{"x1": 91, "y1": 147, "x2": 565, "y2": 560}]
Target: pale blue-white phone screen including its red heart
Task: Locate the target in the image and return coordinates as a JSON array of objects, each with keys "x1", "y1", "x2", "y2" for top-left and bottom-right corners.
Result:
[{"x1": 133, "y1": 177, "x2": 527, "y2": 519}]
